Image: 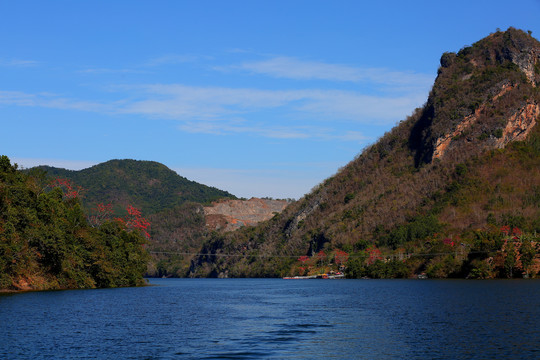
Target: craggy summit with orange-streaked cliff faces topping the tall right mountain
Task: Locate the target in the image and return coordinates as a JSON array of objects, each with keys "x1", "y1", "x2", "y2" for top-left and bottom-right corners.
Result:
[{"x1": 422, "y1": 28, "x2": 540, "y2": 161}]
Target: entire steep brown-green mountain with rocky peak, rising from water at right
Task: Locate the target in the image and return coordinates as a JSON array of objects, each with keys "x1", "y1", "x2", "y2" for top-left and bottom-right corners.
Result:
[{"x1": 190, "y1": 28, "x2": 540, "y2": 278}]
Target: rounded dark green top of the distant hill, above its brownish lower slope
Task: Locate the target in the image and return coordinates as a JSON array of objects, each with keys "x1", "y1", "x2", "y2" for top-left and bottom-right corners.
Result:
[{"x1": 34, "y1": 160, "x2": 236, "y2": 215}]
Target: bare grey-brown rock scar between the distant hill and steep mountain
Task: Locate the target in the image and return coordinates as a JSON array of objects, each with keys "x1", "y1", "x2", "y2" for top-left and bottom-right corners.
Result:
[{"x1": 204, "y1": 198, "x2": 287, "y2": 231}]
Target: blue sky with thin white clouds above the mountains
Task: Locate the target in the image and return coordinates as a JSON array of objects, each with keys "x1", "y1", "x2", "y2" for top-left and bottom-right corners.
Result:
[{"x1": 0, "y1": 0, "x2": 540, "y2": 198}]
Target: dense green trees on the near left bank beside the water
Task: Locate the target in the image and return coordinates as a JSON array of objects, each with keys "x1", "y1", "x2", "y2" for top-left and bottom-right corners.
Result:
[{"x1": 0, "y1": 156, "x2": 148, "y2": 290}]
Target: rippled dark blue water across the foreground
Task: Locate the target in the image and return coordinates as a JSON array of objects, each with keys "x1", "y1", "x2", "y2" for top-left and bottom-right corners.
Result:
[{"x1": 0, "y1": 279, "x2": 540, "y2": 359}]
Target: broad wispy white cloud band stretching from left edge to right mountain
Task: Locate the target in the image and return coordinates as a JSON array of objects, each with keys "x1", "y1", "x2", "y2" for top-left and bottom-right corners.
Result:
[{"x1": 0, "y1": 84, "x2": 422, "y2": 141}]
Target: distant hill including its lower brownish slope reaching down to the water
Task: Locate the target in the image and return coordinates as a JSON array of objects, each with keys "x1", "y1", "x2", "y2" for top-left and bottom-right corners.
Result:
[{"x1": 32, "y1": 159, "x2": 236, "y2": 276}]
